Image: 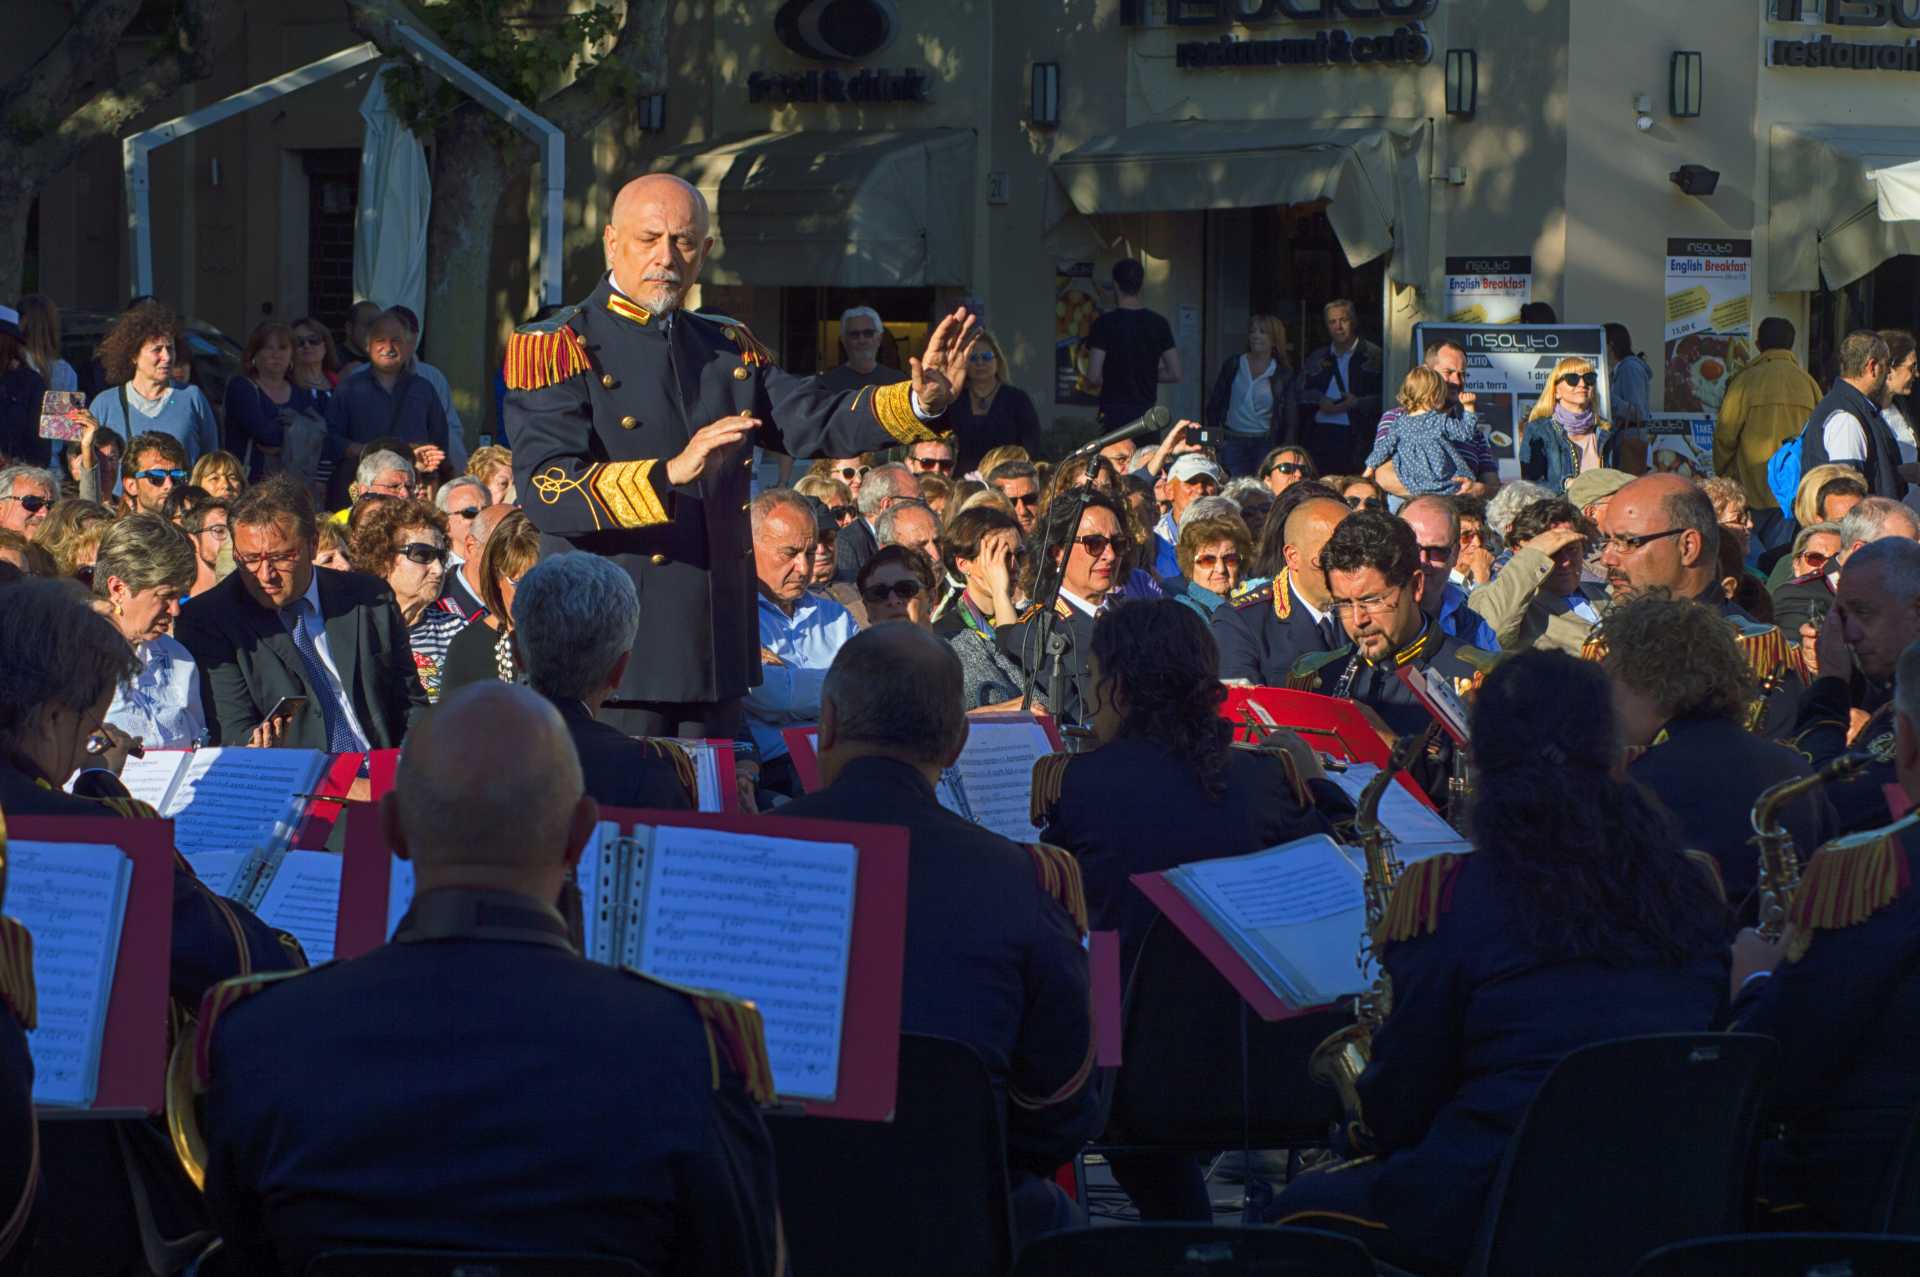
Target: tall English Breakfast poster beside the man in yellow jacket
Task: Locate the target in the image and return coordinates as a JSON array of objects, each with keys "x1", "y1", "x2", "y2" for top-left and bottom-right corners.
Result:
[{"x1": 1667, "y1": 238, "x2": 1759, "y2": 413}]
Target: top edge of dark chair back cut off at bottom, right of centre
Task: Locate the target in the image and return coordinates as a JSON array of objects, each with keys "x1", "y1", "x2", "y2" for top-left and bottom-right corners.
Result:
[{"x1": 1014, "y1": 1223, "x2": 1375, "y2": 1277}]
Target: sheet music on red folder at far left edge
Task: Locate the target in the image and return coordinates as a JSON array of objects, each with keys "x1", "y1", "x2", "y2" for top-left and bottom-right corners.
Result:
[{"x1": 6, "y1": 841, "x2": 131, "y2": 1108}]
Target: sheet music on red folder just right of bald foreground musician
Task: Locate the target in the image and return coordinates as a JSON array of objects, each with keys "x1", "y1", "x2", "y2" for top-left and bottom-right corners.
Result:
[{"x1": 639, "y1": 826, "x2": 858, "y2": 1100}]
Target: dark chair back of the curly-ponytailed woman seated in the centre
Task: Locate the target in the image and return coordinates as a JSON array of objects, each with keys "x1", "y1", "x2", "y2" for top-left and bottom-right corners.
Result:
[{"x1": 1102, "y1": 918, "x2": 1354, "y2": 1150}]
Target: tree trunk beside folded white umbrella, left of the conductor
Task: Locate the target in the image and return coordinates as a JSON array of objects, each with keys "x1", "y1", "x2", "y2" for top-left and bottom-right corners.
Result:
[{"x1": 424, "y1": 108, "x2": 514, "y2": 447}]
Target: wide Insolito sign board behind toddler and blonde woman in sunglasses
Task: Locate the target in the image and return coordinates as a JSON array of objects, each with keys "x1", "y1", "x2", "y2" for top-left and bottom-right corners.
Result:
[{"x1": 1388, "y1": 325, "x2": 1613, "y2": 478}]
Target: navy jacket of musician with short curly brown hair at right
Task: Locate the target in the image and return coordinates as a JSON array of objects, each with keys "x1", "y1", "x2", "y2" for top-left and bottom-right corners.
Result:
[{"x1": 1626, "y1": 718, "x2": 1835, "y2": 926}]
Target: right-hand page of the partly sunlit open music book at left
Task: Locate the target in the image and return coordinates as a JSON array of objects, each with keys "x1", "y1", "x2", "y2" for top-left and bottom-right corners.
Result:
[{"x1": 159, "y1": 749, "x2": 328, "y2": 862}]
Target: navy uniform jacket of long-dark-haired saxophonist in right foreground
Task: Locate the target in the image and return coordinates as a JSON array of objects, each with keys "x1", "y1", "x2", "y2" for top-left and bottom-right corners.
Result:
[{"x1": 1273, "y1": 853, "x2": 1726, "y2": 1273}]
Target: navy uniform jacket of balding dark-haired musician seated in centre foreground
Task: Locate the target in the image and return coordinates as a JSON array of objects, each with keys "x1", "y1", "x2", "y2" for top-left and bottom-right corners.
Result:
[{"x1": 780, "y1": 757, "x2": 1100, "y2": 1198}]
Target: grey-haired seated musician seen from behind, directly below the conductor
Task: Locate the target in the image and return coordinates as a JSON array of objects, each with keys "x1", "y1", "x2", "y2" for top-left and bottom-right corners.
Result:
[{"x1": 513, "y1": 551, "x2": 699, "y2": 810}]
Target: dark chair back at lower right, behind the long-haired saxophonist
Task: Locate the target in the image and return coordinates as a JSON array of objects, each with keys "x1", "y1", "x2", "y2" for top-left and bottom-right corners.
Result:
[{"x1": 1469, "y1": 1033, "x2": 1776, "y2": 1277}]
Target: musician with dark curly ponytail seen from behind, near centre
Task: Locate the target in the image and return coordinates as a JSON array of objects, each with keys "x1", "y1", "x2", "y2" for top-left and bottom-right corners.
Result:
[{"x1": 1033, "y1": 599, "x2": 1352, "y2": 1219}]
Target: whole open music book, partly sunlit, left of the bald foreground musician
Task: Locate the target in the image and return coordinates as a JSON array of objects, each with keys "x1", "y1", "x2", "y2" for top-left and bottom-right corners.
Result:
[{"x1": 121, "y1": 747, "x2": 332, "y2": 871}]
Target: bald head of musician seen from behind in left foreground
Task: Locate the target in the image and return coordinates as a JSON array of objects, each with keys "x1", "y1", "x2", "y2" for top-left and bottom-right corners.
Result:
[{"x1": 380, "y1": 682, "x2": 599, "y2": 901}]
